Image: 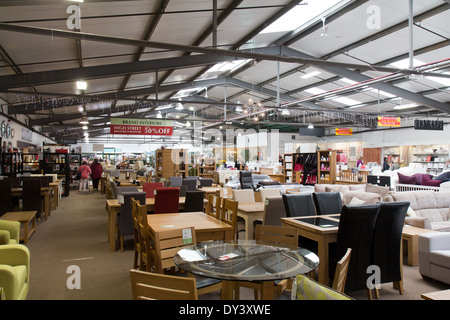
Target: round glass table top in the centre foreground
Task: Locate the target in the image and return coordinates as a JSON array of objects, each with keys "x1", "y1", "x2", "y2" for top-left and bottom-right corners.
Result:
[{"x1": 174, "y1": 240, "x2": 319, "y2": 281}]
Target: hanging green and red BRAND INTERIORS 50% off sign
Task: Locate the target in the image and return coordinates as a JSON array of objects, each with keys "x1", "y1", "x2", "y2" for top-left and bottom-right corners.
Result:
[{"x1": 110, "y1": 118, "x2": 173, "y2": 136}]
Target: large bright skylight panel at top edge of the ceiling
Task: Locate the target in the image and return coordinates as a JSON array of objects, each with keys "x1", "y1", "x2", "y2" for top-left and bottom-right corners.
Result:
[{"x1": 260, "y1": 0, "x2": 347, "y2": 34}]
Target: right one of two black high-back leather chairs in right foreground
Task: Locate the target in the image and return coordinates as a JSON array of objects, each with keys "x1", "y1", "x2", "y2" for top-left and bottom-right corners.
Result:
[{"x1": 372, "y1": 202, "x2": 410, "y2": 298}]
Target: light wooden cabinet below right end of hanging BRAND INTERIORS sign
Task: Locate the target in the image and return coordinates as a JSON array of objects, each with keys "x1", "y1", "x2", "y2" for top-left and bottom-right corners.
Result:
[{"x1": 155, "y1": 149, "x2": 189, "y2": 179}]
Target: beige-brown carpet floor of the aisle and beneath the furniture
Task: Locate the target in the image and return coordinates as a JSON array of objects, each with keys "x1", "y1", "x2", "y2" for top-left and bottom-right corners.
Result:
[{"x1": 26, "y1": 190, "x2": 450, "y2": 300}]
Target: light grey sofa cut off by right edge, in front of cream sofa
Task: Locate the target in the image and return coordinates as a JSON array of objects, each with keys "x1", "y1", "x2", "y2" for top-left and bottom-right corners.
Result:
[{"x1": 419, "y1": 232, "x2": 450, "y2": 284}]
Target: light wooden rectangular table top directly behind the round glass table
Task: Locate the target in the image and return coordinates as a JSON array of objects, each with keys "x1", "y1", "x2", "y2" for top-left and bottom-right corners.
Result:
[{"x1": 147, "y1": 211, "x2": 233, "y2": 242}]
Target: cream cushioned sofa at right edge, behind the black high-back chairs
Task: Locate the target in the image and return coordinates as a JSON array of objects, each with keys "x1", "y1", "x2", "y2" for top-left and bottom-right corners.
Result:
[{"x1": 383, "y1": 191, "x2": 450, "y2": 231}]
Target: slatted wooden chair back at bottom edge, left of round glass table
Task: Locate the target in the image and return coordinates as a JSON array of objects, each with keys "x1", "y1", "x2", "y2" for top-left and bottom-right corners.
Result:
[{"x1": 130, "y1": 270, "x2": 198, "y2": 300}]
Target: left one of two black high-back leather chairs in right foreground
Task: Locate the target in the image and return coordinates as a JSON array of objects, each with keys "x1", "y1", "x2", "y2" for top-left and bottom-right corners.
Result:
[{"x1": 329, "y1": 204, "x2": 380, "y2": 298}]
